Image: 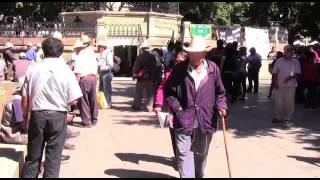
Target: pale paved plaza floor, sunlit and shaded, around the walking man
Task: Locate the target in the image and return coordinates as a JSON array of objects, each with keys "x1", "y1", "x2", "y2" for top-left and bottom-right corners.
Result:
[{"x1": 60, "y1": 80, "x2": 320, "y2": 178}]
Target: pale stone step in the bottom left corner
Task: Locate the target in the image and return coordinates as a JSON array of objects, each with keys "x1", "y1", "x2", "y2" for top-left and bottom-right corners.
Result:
[{"x1": 0, "y1": 143, "x2": 27, "y2": 178}]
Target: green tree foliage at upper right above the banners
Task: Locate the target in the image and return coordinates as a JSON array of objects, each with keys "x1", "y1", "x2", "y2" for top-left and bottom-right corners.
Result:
[{"x1": 180, "y1": 2, "x2": 320, "y2": 39}]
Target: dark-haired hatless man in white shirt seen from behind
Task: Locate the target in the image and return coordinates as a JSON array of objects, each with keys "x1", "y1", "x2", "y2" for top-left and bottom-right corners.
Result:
[{"x1": 22, "y1": 38, "x2": 82, "y2": 178}]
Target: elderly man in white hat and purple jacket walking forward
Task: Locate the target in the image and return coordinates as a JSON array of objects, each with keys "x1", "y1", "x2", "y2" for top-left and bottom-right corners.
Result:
[{"x1": 165, "y1": 37, "x2": 227, "y2": 178}]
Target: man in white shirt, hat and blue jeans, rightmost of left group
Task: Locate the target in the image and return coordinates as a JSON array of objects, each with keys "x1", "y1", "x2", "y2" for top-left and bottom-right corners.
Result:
[{"x1": 98, "y1": 41, "x2": 113, "y2": 109}]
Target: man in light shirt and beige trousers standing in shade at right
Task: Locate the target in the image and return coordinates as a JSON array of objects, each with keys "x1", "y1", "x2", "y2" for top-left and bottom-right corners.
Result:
[{"x1": 272, "y1": 45, "x2": 301, "y2": 123}]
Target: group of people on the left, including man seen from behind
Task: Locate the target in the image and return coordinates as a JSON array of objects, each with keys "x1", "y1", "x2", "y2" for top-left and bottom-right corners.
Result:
[{"x1": 0, "y1": 34, "x2": 121, "y2": 177}]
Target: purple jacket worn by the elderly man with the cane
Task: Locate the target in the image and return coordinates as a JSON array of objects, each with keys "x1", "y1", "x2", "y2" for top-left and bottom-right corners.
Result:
[{"x1": 165, "y1": 60, "x2": 227, "y2": 135}]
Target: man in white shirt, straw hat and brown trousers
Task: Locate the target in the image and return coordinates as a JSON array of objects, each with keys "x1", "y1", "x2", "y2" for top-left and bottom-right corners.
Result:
[{"x1": 74, "y1": 35, "x2": 99, "y2": 128}]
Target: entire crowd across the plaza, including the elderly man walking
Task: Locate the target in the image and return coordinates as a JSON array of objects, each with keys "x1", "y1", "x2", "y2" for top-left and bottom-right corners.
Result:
[{"x1": 0, "y1": 30, "x2": 320, "y2": 178}]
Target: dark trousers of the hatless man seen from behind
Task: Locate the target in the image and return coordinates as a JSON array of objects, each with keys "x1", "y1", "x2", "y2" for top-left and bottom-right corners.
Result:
[{"x1": 22, "y1": 111, "x2": 67, "y2": 178}]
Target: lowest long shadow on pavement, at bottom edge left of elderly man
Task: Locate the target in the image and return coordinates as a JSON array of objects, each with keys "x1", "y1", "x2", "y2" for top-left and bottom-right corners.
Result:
[{"x1": 104, "y1": 169, "x2": 176, "y2": 178}]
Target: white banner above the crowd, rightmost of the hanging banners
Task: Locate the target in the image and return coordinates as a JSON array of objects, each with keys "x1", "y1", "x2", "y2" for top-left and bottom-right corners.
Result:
[{"x1": 245, "y1": 27, "x2": 271, "y2": 59}]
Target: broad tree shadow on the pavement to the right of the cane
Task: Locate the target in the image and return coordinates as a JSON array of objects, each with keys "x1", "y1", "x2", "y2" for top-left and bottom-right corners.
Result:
[{"x1": 219, "y1": 83, "x2": 320, "y2": 155}]
